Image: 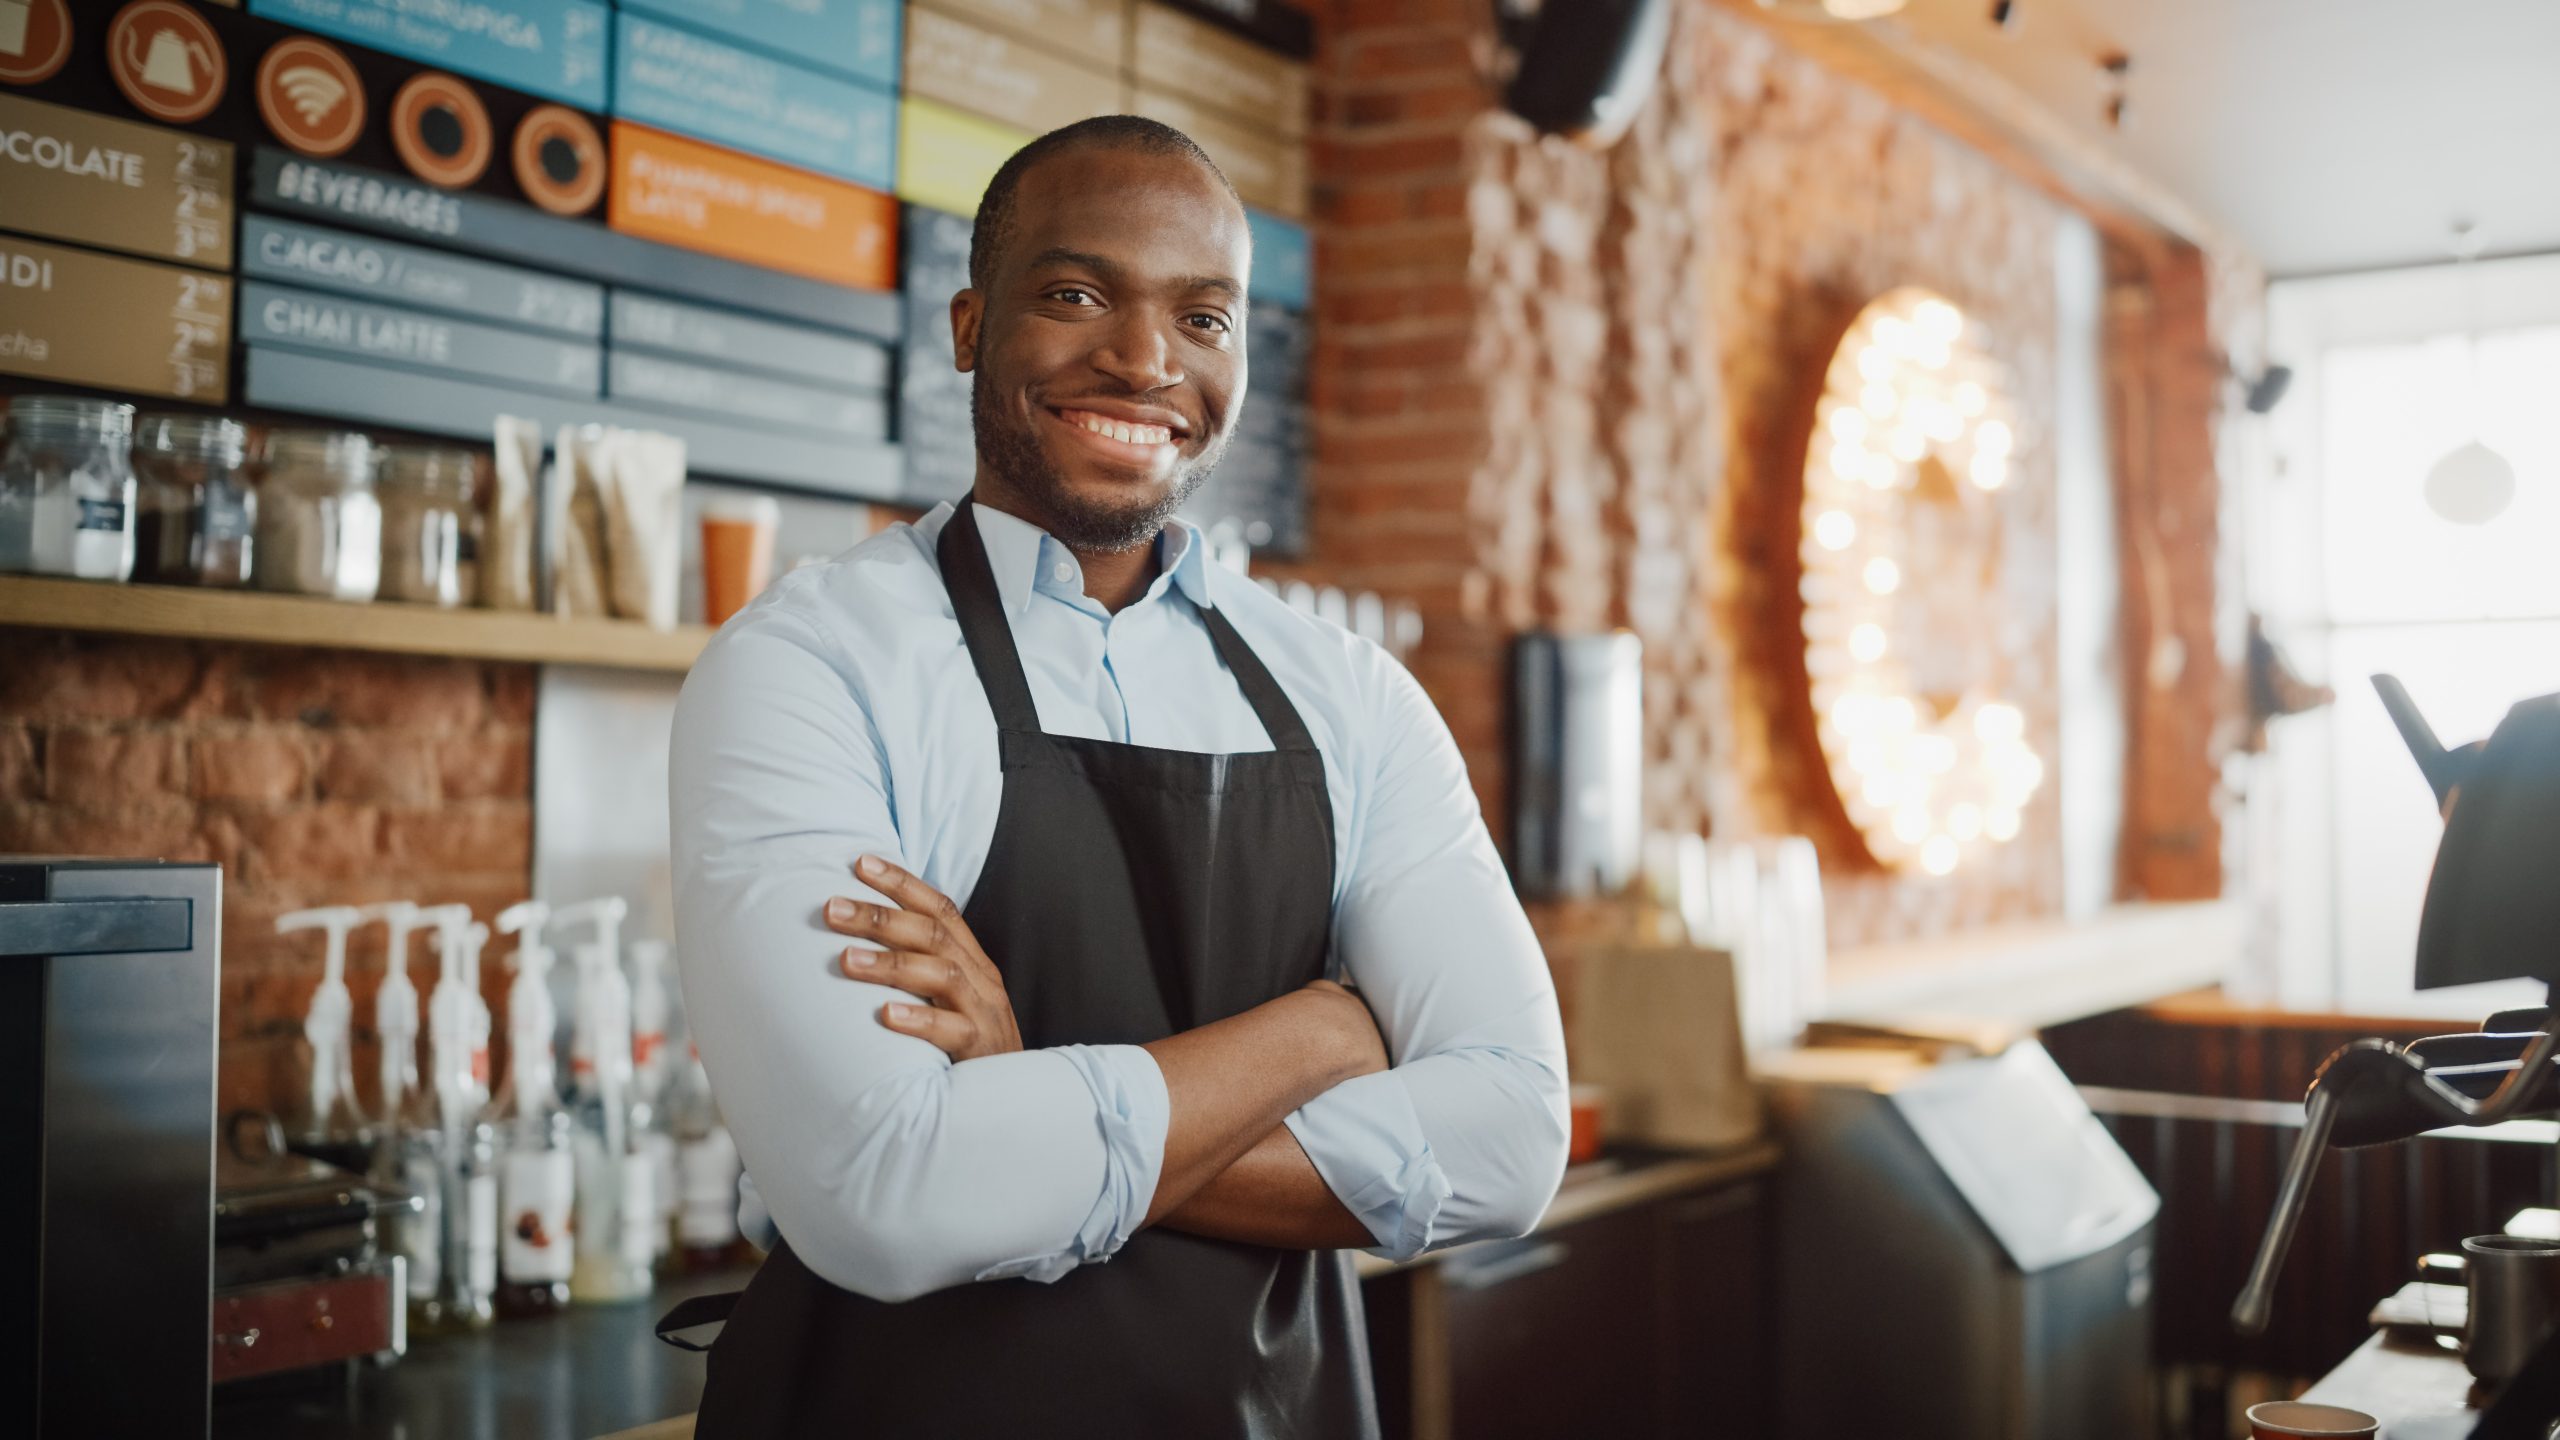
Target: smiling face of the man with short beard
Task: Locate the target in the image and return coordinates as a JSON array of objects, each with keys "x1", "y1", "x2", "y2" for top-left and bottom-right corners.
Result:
[{"x1": 952, "y1": 149, "x2": 1252, "y2": 551}]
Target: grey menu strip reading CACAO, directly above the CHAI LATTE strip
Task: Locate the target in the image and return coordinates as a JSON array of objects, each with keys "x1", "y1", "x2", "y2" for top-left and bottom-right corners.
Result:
[{"x1": 241, "y1": 215, "x2": 604, "y2": 341}]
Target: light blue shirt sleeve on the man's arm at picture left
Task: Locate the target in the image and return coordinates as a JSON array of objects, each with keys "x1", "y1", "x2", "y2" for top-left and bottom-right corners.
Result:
[{"x1": 668, "y1": 607, "x2": 1170, "y2": 1302}]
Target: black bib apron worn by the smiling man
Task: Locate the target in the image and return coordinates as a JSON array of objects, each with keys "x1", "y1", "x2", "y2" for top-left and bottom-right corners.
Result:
[{"x1": 660, "y1": 502, "x2": 1377, "y2": 1440}]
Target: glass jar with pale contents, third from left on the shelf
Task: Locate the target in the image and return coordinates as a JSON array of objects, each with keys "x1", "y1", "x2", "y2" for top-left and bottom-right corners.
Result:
[{"x1": 256, "y1": 430, "x2": 381, "y2": 600}]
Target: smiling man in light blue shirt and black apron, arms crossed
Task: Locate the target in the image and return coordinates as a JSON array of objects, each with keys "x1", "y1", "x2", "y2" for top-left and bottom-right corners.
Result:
[{"x1": 673, "y1": 115, "x2": 1564, "y2": 1440}]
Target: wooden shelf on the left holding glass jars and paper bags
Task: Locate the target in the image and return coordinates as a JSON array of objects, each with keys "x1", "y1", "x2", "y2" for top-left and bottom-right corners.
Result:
[{"x1": 0, "y1": 574, "x2": 712, "y2": 671}]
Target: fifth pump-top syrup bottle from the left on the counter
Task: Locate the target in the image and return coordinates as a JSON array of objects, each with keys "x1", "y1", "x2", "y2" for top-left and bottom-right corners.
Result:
[{"x1": 550, "y1": 897, "x2": 658, "y2": 1304}]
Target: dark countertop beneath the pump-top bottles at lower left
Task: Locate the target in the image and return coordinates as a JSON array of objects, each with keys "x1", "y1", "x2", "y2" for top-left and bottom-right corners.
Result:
[{"x1": 212, "y1": 1271, "x2": 753, "y2": 1440}]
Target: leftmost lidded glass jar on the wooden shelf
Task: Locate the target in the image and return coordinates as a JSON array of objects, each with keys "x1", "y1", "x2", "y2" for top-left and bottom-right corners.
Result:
[{"x1": 0, "y1": 395, "x2": 133, "y2": 579}]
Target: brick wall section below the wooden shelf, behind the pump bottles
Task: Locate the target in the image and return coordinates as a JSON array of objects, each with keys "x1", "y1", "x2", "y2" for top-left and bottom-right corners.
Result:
[{"x1": 0, "y1": 630, "x2": 532, "y2": 1107}]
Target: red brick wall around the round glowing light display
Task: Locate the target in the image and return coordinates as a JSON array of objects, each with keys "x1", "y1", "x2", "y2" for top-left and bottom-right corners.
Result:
[{"x1": 1295, "y1": 0, "x2": 2252, "y2": 943}]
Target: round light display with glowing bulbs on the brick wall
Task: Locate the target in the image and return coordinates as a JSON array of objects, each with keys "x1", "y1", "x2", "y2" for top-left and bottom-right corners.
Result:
[{"x1": 1802, "y1": 287, "x2": 2045, "y2": 874}]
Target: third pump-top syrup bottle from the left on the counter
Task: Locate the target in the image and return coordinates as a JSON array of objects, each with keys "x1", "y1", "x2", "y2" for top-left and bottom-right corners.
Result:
[{"x1": 420, "y1": 904, "x2": 497, "y2": 1330}]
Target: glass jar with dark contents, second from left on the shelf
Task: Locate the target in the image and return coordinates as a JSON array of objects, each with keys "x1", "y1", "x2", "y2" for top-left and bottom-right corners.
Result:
[{"x1": 133, "y1": 415, "x2": 259, "y2": 589}]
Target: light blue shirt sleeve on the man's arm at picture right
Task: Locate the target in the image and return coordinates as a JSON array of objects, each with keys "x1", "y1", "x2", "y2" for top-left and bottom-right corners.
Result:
[{"x1": 1288, "y1": 648, "x2": 1567, "y2": 1258}]
